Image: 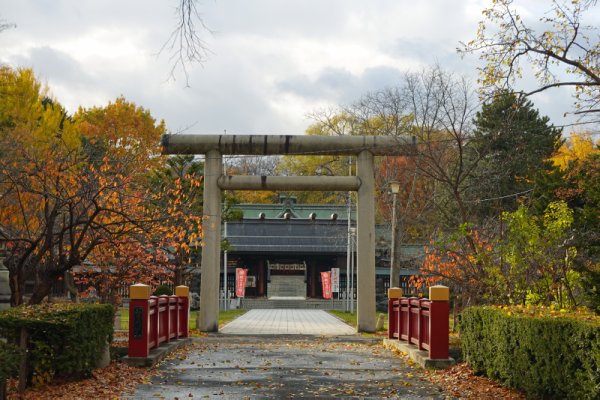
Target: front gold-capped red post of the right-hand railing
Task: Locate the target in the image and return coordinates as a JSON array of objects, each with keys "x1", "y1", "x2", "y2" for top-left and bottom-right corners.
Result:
[{"x1": 429, "y1": 286, "x2": 450, "y2": 360}]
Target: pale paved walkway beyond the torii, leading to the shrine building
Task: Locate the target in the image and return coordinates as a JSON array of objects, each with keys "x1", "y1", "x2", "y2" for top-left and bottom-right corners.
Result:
[{"x1": 220, "y1": 309, "x2": 356, "y2": 336}]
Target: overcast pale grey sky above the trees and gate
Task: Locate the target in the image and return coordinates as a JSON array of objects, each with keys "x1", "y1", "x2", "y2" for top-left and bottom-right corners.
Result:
[{"x1": 0, "y1": 0, "x2": 592, "y2": 134}]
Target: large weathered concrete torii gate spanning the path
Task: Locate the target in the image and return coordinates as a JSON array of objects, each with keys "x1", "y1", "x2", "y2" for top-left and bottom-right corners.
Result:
[{"x1": 161, "y1": 134, "x2": 414, "y2": 332}]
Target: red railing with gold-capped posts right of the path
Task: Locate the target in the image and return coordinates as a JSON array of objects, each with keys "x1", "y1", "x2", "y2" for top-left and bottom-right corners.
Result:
[{"x1": 388, "y1": 286, "x2": 450, "y2": 360}]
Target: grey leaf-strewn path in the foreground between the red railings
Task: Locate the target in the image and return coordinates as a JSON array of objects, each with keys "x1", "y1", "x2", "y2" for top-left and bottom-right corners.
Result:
[{"x1": 125, "y1": 334, "x2": 446, "y2": 399}]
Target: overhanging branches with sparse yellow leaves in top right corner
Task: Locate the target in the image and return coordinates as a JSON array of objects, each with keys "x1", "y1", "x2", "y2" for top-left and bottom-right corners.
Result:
[{"x1": 459, "y1": 0, "x2": 600, "y2": 121}]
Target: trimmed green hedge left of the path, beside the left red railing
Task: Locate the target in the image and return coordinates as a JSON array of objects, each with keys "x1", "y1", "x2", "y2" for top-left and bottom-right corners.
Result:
[{"x1": 0, "y1": 304, "x2": 114, "y2": 383}]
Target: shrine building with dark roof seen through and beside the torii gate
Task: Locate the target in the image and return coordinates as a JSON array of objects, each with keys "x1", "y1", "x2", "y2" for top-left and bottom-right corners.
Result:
[{"x1": 221, "y1": 197, "x2": 423, "y2": 299}]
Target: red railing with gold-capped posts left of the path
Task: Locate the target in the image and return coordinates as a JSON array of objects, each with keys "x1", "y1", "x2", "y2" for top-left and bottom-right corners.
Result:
[{"x1": 128, "y1": 284, "x2": 190, "y2": 357}]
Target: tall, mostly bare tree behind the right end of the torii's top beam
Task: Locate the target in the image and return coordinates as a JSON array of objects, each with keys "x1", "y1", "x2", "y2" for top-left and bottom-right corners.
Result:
[{"x1": 347, "y1": 67, "x2": 482, "y2": 234}]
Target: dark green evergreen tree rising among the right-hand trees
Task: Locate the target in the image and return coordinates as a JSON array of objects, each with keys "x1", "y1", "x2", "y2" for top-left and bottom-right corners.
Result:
[{"x1": 471, "y1": 92, "x2": 562, "y2": 217}]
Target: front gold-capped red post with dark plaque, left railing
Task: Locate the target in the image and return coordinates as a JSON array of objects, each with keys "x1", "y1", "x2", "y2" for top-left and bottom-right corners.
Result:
[{"x1": 127, "y1": 284, "x2": 150, "y2": 357}]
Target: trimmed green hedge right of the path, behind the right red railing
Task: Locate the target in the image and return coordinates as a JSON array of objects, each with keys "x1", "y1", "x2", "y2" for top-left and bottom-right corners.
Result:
[{"x1": 460, "y1": 307, "x2": 600, "y2": 399}]
